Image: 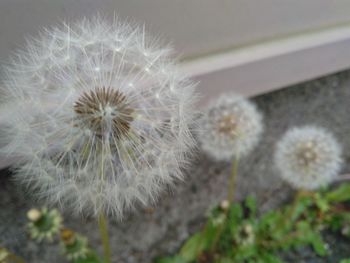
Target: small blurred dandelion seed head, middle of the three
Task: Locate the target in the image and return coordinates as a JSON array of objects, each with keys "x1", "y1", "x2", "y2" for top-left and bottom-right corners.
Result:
[{"x1": 199, "y1": 93, "x2": 263, "y2": 160}]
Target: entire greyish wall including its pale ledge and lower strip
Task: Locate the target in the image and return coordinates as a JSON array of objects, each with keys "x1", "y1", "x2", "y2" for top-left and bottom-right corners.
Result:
[{"x1": 0, "y1": 0, "x2": 350, "y2": 104}]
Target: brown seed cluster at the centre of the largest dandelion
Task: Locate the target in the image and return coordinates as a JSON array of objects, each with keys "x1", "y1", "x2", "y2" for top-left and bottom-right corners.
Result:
[{"x1": 74, "y1": 87, "x2": 133, "y2": 139}]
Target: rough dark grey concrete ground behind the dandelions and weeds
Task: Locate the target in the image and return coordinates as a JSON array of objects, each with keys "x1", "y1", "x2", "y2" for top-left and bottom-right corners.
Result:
[{"x1": 0, "y1": 72, "x2": 350, "y2": 263}]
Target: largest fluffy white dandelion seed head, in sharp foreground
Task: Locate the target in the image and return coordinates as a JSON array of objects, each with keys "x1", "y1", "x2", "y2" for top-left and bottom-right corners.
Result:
[{"x1": 1, "y1": 17, "x2": 195, "y2": 219}]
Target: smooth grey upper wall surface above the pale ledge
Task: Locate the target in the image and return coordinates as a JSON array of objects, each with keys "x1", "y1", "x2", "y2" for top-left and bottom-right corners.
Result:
[{"x1": 0, "y1": 0, "x2": 350, "y2": 61}]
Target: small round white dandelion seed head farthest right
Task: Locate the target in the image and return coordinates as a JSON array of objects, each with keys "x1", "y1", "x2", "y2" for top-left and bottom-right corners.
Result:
[{"x1": 274, "y1": 126, "x2": 342, "y2": 190}]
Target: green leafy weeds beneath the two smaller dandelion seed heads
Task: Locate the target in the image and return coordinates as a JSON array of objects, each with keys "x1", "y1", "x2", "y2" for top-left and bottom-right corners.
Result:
[{"x1": 156, "y1": 184, "x2": 350, "y2": 263}]
